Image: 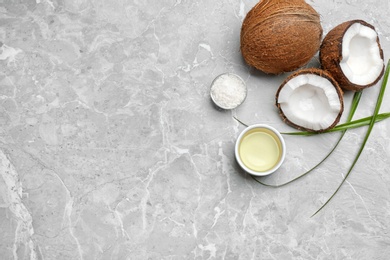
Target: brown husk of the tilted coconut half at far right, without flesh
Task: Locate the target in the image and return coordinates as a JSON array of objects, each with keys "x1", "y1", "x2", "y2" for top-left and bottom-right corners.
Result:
[{"x1": 319, "y1": 20, "x2": 385, "y2": 91}]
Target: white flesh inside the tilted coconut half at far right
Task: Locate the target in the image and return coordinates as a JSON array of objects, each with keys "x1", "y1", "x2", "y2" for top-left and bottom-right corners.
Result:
[{"x1": 340, "y1": 23, "x2": 383, "y2": 86}]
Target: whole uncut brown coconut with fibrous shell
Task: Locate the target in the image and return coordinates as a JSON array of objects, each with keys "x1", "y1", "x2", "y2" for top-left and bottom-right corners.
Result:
[{"x1": 241, "y1": 0, "x2": 322, "y2": 74}]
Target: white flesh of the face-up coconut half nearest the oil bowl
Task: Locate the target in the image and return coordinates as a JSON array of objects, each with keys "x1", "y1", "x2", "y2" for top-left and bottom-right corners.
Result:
[{"x1": 278, "y1": 74, "x2": 342, "y2": 131}]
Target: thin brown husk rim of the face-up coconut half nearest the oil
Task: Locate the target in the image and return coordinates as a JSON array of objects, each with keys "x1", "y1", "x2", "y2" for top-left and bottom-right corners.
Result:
[{"x1": 275, "y1": 68, "x2": 344, "y2": 133}]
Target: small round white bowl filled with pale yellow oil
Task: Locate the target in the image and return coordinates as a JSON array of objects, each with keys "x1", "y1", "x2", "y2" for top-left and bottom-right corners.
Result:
[{"x1": 235, "y1": 124, "x2": 286, "y2": 176}]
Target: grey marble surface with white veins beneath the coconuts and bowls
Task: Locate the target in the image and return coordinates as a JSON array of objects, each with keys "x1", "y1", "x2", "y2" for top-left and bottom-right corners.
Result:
[{"x1": 0, "y1": 0, "x2": 390, "y2": 260}]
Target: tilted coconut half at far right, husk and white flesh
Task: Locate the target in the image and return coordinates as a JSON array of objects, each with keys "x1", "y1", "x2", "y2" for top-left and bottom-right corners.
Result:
[{"x1": 319, "y1": 20, "x2": 385, "y2": 91}]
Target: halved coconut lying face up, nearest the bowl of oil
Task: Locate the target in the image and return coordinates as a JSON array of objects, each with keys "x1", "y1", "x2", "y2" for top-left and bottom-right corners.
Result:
[{"x1": 276, "y1": 68, "x2": 344, "y2": 132}]
